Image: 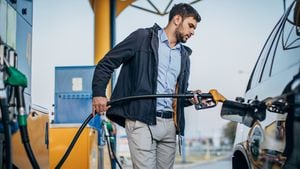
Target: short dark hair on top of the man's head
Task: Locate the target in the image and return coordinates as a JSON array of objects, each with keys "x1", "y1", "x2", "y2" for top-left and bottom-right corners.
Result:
[{"x1": 169, "y1": 3, "x2": 201, "y2": 22}]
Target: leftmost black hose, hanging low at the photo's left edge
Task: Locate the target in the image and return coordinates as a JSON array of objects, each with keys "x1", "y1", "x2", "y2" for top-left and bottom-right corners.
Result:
[{"x1": 0, "y1": 99, "x2": 12, "y2": 169}]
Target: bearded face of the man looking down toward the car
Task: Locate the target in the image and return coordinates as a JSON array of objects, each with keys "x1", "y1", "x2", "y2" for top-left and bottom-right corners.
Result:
[{"x1": 175, "y1": 17, "x2": 197, "y2": 43}]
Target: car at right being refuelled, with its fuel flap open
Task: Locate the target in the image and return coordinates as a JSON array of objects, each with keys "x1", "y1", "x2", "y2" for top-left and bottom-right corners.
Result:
[{"x1": 221, "y1": 0, "x2": 300, "y2": 169}]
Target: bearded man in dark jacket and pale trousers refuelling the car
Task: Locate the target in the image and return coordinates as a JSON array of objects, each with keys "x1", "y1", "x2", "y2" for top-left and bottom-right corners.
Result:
[{"x1": 93, "y1": 3, "x2": 201, "y2": 169}]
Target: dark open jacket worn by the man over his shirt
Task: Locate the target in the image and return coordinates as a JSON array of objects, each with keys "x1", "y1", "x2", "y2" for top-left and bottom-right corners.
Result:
[{"x1": 92, "y1": 24, "x2": 192, "y2": 135}]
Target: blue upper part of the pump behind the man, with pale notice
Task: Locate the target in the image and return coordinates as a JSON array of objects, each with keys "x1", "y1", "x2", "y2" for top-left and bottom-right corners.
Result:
[{"x1": 54, "y1": 66, "x2": 100, "y2": 128}]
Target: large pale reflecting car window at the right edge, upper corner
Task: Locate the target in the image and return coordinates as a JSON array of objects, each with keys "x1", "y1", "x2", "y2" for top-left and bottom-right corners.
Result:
[{"x1": 271, "y1": 2, "x2": 300, "y2": 75}]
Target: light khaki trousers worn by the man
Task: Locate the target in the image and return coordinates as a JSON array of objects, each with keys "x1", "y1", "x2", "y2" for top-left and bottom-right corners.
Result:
[{"x1": 125, "y1": 117, "x2": 176, "y2": 169}]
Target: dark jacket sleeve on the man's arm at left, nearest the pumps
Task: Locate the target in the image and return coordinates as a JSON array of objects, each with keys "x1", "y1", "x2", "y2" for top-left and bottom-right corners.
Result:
[{"x1": 92, "y1": 31, "x2": 138, "y2": 97}]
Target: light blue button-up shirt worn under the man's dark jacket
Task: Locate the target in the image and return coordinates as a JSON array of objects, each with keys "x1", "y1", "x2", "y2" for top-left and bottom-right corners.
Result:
[{"x1": 156, "y1": 29, "x2": 181, "y2": 111}]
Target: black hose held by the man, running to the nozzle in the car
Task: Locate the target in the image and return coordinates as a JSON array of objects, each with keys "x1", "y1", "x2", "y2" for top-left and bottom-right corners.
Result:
[{"x1": 55, "y1": 93, "x2": 212, "y2": 169}]
